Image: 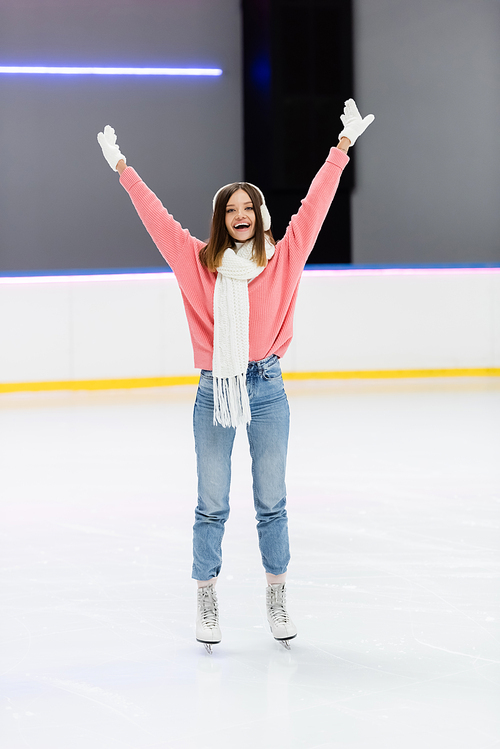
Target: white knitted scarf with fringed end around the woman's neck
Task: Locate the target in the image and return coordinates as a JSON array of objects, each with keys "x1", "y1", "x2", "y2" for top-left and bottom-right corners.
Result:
[{"x1": 212, "y1": 238, "x2": 274, "y2": 427}]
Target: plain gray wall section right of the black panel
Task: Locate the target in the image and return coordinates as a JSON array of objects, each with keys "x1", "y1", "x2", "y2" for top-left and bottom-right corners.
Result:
[{"x1": 353, "y1": 0, "x2": 500, "y2": 264}]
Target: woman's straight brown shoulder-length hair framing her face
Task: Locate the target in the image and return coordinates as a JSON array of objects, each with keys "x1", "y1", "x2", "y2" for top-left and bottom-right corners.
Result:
[{"x1": 199, "y1": 182, "x2": 276, "y2": 272}]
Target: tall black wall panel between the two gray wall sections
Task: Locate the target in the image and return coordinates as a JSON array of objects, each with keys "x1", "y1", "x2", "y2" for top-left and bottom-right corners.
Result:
[{"x1": 243, "y1": 0, "x2": 353, "y2": 263}]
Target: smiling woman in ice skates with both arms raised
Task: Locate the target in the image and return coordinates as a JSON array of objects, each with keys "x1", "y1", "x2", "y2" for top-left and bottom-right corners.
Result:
[{"x1": 97, "y1": 99, "x2": 374, "y2": 652}]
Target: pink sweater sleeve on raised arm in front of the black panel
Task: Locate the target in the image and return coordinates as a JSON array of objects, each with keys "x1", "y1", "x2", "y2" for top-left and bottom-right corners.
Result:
[{"x1": 279, "y1": 148, "x2": 350, "y2": 267}]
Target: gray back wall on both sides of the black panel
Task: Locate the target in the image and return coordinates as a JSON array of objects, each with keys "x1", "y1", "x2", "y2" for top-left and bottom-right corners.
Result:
[{"x1": 0, "y1": 0, "x2": 500, "y2": 272}]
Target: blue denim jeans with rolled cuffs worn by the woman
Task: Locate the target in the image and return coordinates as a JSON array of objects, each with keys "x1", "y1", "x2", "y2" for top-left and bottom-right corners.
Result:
[{"x1": 193, "y1": 354, "x2": 290, "y2": 580}]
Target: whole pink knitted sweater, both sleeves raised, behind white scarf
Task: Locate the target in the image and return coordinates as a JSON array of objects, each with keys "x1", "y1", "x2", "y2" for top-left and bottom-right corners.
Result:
[{"x1": 120, "y1": 148, "x2": 349, "y2": 369}]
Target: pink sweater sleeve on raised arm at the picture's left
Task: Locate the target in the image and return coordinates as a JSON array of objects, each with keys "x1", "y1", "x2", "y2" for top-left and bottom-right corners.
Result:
[{"x1": 120, "y1": 166, "x2": 204, "y2": 273}]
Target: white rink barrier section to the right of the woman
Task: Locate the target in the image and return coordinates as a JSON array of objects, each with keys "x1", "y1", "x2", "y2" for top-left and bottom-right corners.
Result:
[{"x1": 286, "y1": 268, "x2": 500, "y2": 371}]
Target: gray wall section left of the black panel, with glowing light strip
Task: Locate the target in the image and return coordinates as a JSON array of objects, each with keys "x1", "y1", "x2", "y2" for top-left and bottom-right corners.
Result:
[{"x1": 0, "y1": 0, "x2": 243, "y2": 271}]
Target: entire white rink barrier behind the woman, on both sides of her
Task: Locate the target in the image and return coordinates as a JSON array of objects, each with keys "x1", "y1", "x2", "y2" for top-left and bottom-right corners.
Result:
[{"x1": 0, "y1": 268, "x2": 500, "y2": 384}]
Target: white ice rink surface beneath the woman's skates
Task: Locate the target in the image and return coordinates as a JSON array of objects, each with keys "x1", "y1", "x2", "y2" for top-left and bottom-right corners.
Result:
[{"x1": 0, "y1": 378, "x2": 500, "y2": 749}]
